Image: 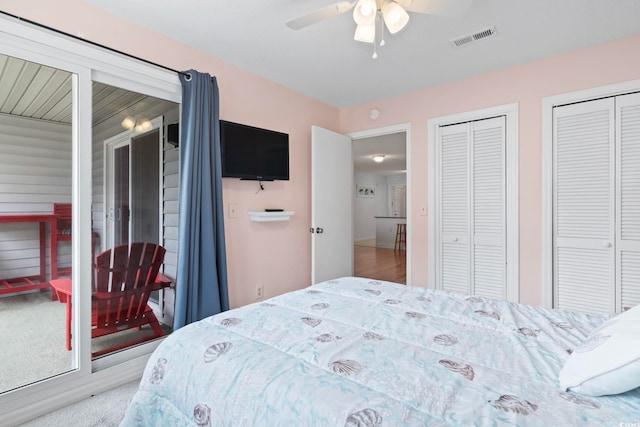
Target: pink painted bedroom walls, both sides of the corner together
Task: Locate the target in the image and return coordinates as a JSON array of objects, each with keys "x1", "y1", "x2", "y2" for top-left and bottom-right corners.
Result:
[{"x1": 2, "y1": 0, "x2": 640, "y2": 307}]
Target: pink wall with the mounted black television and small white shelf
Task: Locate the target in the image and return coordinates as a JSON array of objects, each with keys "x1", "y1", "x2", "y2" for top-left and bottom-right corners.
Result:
[{"x1": 2, "y1": 0, "x2": 339, "y2": 307}]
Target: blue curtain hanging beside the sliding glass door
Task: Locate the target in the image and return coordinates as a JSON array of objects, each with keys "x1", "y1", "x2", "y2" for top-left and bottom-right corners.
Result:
[{"x1": 173, "y1": 70, "x2": 229, "y2": 330}]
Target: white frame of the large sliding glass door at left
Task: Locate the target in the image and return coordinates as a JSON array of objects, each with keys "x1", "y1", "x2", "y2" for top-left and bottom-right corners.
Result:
[{"x1": 0, "y1": 16, "x2": 182, "y2": 424}]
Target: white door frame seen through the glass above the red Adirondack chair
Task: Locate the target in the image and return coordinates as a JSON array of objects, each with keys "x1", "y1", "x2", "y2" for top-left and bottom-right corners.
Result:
[{"x1": 103, "y1": 116, "x2": 163, "y2": 248}]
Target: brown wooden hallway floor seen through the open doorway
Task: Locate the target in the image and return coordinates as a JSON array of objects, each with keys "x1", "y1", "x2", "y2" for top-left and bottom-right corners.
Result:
[{"x1": 353, "y1": 245, "x2": 407, "y2": 284}]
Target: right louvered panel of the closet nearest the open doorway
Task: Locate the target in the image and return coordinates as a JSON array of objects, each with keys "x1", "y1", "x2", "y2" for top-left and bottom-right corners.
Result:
[{"x1": 470, "y1": 117, "x2": 506, "y2": 299}]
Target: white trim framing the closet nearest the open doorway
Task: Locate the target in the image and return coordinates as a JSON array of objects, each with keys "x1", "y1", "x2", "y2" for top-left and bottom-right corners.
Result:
[{"x1": 427, "y1": 103, "x2": 520, "y2": 302}]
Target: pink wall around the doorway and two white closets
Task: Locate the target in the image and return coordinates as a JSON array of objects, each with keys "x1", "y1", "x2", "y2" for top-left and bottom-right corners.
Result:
[{"x1": 340, "y1": 36, "x2": 640, "y2": 304}]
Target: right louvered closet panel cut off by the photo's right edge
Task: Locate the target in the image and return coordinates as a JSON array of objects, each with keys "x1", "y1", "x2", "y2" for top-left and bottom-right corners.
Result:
[{"x1": 616, "y1": 94, "x2": 640, "y2": 311}]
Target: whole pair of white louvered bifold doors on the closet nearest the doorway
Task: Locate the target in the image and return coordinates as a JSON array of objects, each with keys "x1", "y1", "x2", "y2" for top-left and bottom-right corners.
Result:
[{"x1": 436, "y1": 117, "x2": 506, "y2": 299}]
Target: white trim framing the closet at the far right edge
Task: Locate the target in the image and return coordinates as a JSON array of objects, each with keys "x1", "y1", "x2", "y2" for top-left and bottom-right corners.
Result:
[{"x1": 541, "y1": 80, "x2": 640, "y2": 308}]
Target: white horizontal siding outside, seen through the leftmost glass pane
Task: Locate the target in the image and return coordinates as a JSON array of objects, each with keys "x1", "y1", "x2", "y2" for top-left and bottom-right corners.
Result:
[{"x1": 0, "y1": 115, "x2": 71, "y2": 279}]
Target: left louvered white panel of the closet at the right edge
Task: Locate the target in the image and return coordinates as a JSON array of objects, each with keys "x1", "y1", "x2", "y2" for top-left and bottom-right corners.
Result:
[{"x1": 553, "y1": 98, "x2": 615, "y2": 313}]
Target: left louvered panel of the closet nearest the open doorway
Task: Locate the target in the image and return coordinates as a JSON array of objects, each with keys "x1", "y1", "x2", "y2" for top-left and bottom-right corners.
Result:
[{"x1": 439, "y1": 124, "x2": 470, "y2": 293}]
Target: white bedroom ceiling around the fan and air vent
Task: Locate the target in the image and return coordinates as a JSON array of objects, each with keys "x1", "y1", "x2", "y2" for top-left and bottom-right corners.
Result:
[{"x1": 86, "y1": 0, "x2": 640, "y2": 108}]
